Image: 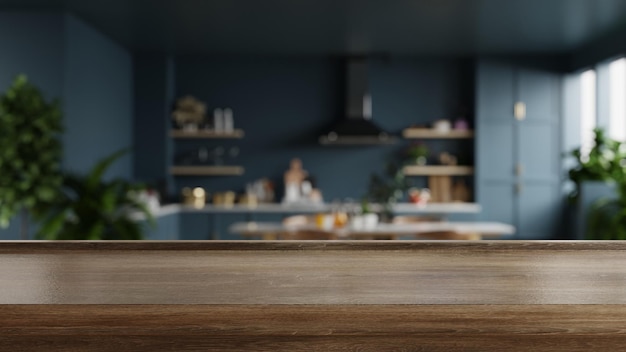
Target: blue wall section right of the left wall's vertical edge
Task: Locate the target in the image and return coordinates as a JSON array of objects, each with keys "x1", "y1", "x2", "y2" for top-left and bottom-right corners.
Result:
[{"x1": 63, "y1": 15, "x2": 134, "y2": 178}]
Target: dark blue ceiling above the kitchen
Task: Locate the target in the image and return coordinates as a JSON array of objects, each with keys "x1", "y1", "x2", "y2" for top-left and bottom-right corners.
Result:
[{"x1": 0, "y1": 0, "x2": 626, "y2": 55}]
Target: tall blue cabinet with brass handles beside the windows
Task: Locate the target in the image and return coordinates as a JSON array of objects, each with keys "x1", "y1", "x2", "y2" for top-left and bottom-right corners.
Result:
[{"x1": 476, "y1": 61, "x2": 562, "y2": 239}]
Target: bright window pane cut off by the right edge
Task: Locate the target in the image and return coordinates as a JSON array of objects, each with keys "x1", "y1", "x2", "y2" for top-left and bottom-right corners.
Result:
[{"x1": 609, "y1": 58, "x2": 626, "y2": 142}]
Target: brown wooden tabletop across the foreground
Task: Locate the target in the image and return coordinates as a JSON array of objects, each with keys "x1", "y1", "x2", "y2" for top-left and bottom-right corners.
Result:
[{"x1": 0, "y1": 241, "x2": 626, "y2": 351}]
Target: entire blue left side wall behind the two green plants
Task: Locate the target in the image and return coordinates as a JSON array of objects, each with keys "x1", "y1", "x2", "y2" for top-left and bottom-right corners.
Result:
[{"x1": 0, "y1": 12, "x2": 133, "y2": 239}]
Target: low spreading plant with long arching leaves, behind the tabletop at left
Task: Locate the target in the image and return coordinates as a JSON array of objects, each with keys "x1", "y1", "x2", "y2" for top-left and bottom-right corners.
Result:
[{"x1": 37, "y1": 150, "x2": 154, "y2": 240}]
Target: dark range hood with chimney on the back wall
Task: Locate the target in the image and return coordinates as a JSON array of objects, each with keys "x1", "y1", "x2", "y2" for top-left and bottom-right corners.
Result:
[{"x1": 319, "y1": 59, "x2": 396, "y2": 145}]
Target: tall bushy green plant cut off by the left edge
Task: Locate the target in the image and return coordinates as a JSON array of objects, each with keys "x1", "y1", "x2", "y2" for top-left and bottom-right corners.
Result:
[{"x1": 0, "y1": 75, "x2": 62, "y2": 227}]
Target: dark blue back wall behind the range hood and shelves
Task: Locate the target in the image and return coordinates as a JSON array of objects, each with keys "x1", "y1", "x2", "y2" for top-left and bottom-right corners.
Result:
[{"x1": 169, "y1": 57, "x2": 473, "y2": 201}]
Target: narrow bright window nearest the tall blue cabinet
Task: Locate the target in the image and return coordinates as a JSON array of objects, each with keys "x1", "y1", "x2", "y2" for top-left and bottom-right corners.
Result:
[{"x1": 580, "y1": 70, "x2": 597, "y2": 160}]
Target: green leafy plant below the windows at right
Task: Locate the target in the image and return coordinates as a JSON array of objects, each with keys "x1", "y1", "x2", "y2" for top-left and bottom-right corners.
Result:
[{"x1": 569, "y1": 128, "x2": 626, "y2": 201}]
